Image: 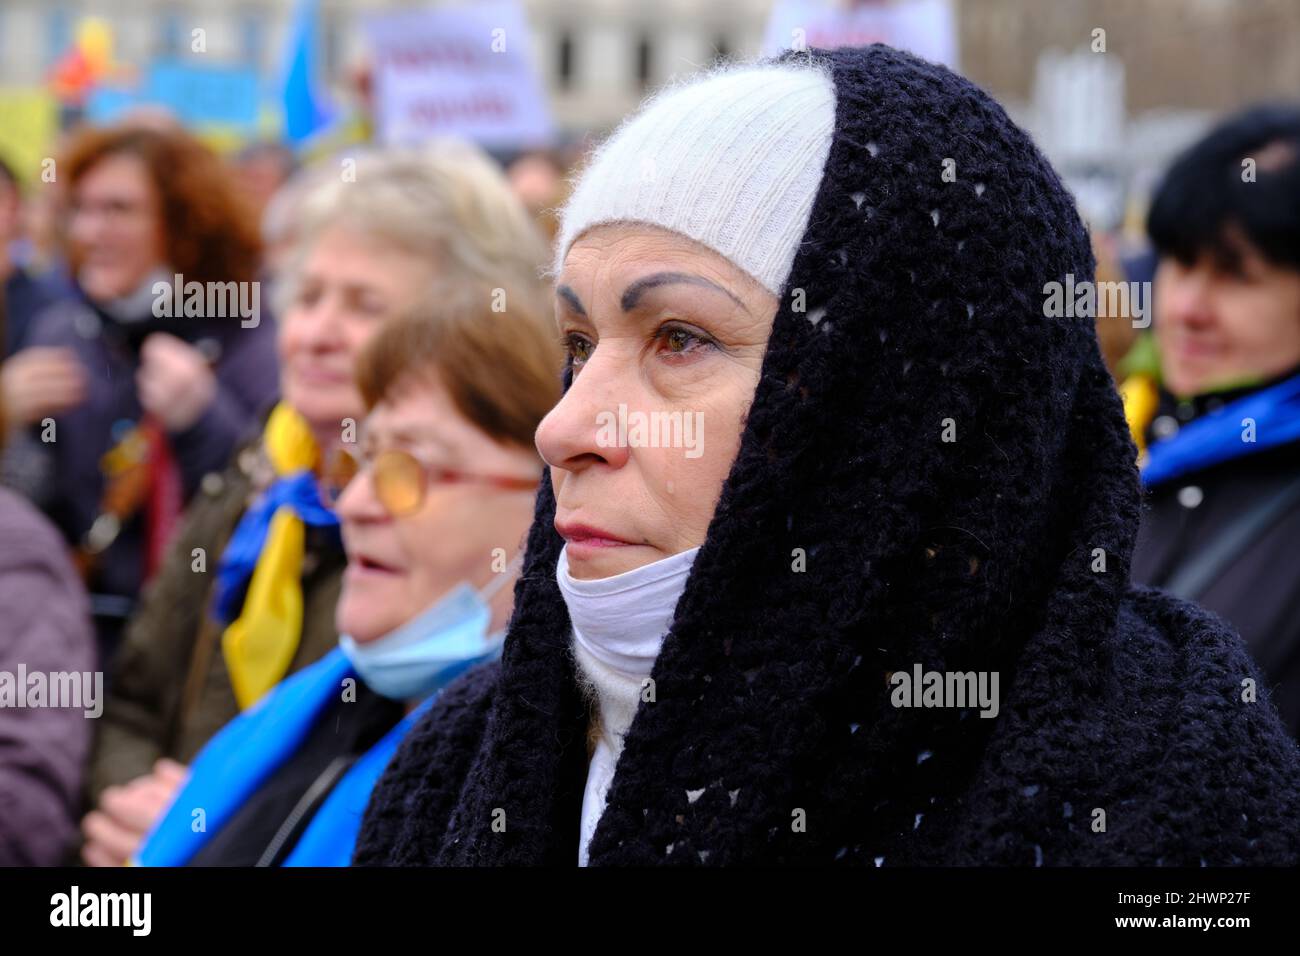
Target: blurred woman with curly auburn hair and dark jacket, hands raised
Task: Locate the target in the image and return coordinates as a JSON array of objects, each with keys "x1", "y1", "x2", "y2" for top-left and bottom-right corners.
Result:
[{"x1": 3, "y1": 126, "x2": 277, "y2": 654}]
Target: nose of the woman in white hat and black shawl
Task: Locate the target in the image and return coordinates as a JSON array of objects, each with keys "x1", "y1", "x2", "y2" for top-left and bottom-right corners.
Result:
[{"x1": 536, "y1": 356, "x2": 633, "y2": 472}]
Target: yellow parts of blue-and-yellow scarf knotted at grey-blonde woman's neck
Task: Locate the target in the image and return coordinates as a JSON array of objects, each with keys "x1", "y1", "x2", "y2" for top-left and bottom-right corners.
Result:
[{"x1": 221, "y1": 402, "x2": 320, "y2": 709}]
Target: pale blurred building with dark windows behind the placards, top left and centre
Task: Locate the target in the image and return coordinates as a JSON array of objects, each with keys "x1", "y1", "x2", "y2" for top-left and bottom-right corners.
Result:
[{"x1": 0, "y1": 0, "x2": 771, "y2": 130}]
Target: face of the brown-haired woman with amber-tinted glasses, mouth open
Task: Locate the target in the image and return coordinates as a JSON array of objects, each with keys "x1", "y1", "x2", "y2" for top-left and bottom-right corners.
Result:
[{"x1": 335, "y1": 378, "x2": 541, "y2": 644}]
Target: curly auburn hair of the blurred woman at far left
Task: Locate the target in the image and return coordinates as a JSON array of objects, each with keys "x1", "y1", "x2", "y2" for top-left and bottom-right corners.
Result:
[{"x1": 60, "y1": 125, "x2": 261, "y2": 282}]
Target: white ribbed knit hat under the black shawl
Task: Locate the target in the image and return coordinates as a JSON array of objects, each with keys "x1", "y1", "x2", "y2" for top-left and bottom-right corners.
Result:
[{"x1": 555, "y1": 64, "x2": 835, "y2": 295}]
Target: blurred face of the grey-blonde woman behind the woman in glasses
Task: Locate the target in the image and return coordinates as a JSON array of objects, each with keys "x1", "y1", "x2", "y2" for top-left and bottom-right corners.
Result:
[{"x1": 280, "y1": 226, "x2": 432, "y2": 437}]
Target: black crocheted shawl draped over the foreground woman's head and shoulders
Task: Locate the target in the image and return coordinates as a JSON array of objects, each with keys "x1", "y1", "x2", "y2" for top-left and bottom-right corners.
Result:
[{"x1": 356, "y1": 46, "x2": 1300, "y2": 866}]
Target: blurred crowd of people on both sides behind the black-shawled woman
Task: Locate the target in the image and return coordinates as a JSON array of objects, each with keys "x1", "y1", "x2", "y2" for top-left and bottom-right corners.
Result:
[{"x1": 0, "y1": 63, "x2": 1300, "y2": 865}]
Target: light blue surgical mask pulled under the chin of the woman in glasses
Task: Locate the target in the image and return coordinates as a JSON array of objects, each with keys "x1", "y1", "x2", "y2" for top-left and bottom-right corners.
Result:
[{"x1": 338, "y1": 572, "x2": 512, "y2": 701}]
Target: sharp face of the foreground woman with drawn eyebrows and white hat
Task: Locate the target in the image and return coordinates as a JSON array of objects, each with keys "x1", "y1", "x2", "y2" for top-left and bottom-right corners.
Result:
[{"x1": 537, "y1": 224, "x2": 777, "y2": 579}]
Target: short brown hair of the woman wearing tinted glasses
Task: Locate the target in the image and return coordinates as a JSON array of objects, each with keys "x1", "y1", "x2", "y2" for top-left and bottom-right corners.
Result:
[{"x1": 356, "y1": 282, "x2": 562, "y2": 449}]
